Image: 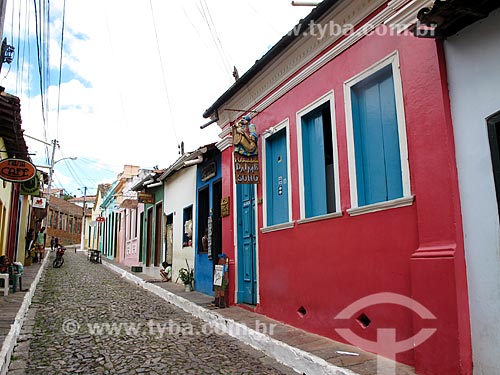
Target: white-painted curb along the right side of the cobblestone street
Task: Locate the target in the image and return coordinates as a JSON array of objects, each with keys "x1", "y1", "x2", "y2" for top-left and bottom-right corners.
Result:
[{"x1": 102, "y1": 260, "x2": 359, "y2": 375}]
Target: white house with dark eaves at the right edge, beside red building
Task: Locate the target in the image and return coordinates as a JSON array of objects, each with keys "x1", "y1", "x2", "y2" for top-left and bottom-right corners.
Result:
[{"x1": 419, "y1": 1, "x2": 500, "y2": 375}]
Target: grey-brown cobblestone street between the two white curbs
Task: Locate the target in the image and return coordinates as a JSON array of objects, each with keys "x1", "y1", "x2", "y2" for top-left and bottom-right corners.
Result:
[{"x1": 8, "y1": 251, "x2": 296, "y2": 375}]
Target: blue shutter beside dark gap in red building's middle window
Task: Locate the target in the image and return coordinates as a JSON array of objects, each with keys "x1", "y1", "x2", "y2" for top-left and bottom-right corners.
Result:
[{"x1": 302, "y1": 110, "x2": 327, "y2": 217}]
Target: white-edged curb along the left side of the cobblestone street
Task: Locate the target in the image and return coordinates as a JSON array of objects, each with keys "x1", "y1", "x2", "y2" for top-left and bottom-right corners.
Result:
[{"x1": 0, "y1": 252, "x2": 50, "y2": 375}]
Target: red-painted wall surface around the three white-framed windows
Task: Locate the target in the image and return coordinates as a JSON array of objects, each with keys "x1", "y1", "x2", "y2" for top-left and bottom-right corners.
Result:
[{"x1": 222, "y1": 27, "x2": 472, "y2": 375}]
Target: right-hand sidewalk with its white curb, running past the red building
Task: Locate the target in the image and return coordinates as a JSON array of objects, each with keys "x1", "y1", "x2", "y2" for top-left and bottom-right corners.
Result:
[{"x1": 102, "y1": 259, "x2": 416, "y2": 375}]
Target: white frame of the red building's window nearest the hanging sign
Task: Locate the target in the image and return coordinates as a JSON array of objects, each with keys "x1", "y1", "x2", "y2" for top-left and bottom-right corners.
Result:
[{"x1": 257, "y1": 118, "x2": 292, "y2": 228}]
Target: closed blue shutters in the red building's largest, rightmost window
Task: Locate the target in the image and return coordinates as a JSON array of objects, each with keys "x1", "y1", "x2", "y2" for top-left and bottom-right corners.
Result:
[{"x1": 352, "y1": 66, "x2": 403, "y2": 206}]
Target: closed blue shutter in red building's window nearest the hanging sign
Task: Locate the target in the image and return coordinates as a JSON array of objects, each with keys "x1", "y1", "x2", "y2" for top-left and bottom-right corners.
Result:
[{"x1": 266, "y1": 129, "x2": 289, "y2": 225}]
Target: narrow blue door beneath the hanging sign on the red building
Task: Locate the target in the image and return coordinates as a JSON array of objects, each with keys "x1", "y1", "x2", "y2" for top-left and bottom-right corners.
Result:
[{"x1": 236, "y1": 184, "x2": 257, "y2": 305}]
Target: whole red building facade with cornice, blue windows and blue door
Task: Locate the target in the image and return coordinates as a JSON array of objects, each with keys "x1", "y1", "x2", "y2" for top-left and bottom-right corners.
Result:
[{"x1": 205, "y1": 1, "x2": 472, "y2": 375}]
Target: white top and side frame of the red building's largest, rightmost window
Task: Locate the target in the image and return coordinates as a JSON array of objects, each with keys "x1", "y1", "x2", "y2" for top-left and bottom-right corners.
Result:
[{"x1": 344, "y1": 51, "x2": 411, "y2": 208}]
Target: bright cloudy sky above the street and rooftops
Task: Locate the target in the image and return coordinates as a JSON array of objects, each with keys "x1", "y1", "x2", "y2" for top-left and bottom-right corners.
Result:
[{"x1": 0, "y1": 0, "x2": 312, "y2": 196}]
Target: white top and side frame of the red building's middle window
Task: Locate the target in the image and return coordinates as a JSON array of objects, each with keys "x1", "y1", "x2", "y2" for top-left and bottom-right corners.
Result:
[{"x1": 295, "y1": 90, "x2": 342, "y2": 220}]
